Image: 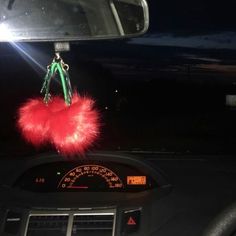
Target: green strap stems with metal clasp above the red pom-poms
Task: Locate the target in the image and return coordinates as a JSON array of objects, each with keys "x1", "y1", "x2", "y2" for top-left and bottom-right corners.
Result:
[{"x1": 40, "y1": 53, "x2": 72, "y2": 106}]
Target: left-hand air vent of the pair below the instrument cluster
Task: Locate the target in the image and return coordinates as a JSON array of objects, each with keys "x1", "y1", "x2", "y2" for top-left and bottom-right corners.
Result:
[{"x1": 26, "y1": 215, "x2": 69, "y2": 236}]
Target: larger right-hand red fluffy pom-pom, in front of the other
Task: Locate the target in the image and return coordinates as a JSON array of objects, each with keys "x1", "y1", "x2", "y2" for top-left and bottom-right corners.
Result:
[{"x1": 49, "y1": 94, "x2": 100, "y2": 156}]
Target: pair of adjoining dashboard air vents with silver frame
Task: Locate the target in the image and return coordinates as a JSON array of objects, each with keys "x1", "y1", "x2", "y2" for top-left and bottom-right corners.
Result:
[{"x1": 24, "y1": 209, "x2": 116, "y2": 236}]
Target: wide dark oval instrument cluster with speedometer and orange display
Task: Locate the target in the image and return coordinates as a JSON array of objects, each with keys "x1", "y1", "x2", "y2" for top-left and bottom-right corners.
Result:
[{"x1": 14, "y1": 160, "x2": 158, "y2": 192}]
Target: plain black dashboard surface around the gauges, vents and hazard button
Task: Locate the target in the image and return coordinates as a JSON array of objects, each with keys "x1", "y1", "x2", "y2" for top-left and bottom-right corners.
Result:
[{"x1": 0, "y1": 153, "x2": 236, "y2": 236}]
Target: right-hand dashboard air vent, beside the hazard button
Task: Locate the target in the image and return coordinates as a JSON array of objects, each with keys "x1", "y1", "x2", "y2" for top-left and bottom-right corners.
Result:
[{"x1": 71, "y1": 214, "x2": 114, "y2": 236}]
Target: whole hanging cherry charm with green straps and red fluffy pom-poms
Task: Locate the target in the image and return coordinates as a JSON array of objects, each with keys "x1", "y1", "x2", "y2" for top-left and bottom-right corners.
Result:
[{"x1": 17, "y1": 53, "x2": 100, "y2": 156}]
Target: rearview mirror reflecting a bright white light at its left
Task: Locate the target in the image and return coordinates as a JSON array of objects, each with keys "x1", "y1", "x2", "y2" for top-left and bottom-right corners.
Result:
[{"x1": 0, "y1": 0, "x2": 149, "y2": 42}]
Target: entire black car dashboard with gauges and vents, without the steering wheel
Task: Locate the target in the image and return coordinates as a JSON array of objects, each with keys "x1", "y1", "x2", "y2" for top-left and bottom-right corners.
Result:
[{"x1": 0, "y1": 152, "x2": 236, "y2": 236}]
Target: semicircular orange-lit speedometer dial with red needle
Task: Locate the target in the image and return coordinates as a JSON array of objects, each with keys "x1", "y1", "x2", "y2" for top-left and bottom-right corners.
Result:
[{"x1": 57, "y1": 165, "x2": 124, "y2": 191}]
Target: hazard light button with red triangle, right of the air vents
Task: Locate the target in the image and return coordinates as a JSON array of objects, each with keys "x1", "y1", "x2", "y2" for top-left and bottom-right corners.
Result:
[{"x1": 122, "y1": 209, "x2": 141, "y2": 235}]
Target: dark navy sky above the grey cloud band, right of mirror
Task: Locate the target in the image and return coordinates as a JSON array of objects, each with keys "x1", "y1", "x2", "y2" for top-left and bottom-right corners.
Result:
[{"x1": 149, "y1": 0, "x2": 236, "y2": 35}]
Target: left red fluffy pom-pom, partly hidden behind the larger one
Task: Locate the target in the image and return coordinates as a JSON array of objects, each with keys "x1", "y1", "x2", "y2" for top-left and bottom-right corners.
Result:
[{"x1": 17, "y1": 98, "x2": 51, "y2": 146}]
